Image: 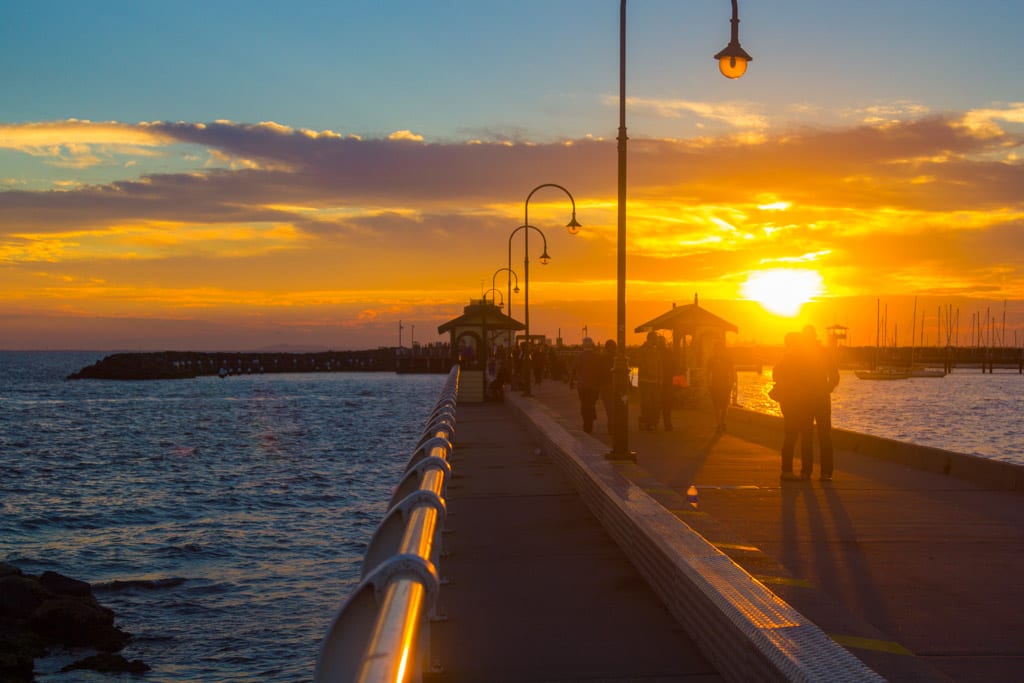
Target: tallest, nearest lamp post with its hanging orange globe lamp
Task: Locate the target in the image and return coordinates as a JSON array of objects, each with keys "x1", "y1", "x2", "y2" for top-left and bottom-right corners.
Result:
[{"x1": 608, "y1": 0, "x2": 753, "y2": 460}]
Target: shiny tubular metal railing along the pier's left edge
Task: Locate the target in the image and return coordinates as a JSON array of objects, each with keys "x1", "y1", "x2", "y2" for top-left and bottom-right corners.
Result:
[{"x1": 313, "y1": 366, "x2": 459, "y2": 683}]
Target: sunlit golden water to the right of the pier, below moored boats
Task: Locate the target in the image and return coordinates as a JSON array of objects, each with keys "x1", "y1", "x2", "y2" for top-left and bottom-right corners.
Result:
[{"x1": 737, "y1": 368, "x2": 1024, "y2": 465}]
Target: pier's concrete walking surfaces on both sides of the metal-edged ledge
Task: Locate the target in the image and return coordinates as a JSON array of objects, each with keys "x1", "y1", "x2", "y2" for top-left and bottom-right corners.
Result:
[{"x1": 430, "y1": 382, "x2": 1024, "y2": 683}]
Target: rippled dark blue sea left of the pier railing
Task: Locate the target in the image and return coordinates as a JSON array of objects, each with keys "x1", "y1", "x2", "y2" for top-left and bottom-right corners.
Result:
[{"x1": 0, "y1": 352, "x2": 445, "y2": 682}]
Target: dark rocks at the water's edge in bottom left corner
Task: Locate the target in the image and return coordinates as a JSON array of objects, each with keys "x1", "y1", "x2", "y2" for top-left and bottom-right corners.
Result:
[{"x1": 0, "y1": 562, "x2": 150, "y2": 683}]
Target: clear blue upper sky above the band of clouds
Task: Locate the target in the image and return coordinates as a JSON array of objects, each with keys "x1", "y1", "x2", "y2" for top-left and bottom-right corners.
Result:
[{"x1": 6, "y1": 0, "x2": 1024, "y2": 139}]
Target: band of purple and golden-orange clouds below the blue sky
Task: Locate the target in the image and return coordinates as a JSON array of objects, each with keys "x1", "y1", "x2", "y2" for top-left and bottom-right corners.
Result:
[{"x1": 0, "y1": 107, "x2": 1024, "y2": 350}]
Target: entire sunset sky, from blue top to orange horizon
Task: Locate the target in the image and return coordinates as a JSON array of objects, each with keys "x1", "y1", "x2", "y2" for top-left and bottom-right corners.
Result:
[{"x1": 0, "y1": 0, "x2": 1024, "y2": 350}]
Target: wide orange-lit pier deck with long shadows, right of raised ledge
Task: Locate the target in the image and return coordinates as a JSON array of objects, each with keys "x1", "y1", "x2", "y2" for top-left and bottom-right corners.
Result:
[{"x1": 513, "y1": 382, "x2": 1024, "y2": 681}]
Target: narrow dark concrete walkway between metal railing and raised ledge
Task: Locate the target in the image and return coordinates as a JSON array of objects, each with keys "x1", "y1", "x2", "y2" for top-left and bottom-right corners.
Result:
[{"x1": 430, "y1": 403, "x2": 723, "y2": 683}]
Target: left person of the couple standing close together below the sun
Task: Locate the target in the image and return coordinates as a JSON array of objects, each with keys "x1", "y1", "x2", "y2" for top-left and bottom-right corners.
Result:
[{"x1": 770, "y1": 332, "x2": 814, "y2": 481}]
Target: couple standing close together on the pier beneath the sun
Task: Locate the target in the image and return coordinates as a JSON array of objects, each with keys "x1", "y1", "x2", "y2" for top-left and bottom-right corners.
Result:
[{"x1": 769, "y1": 326, "x2": 839, "y2": 481}]
